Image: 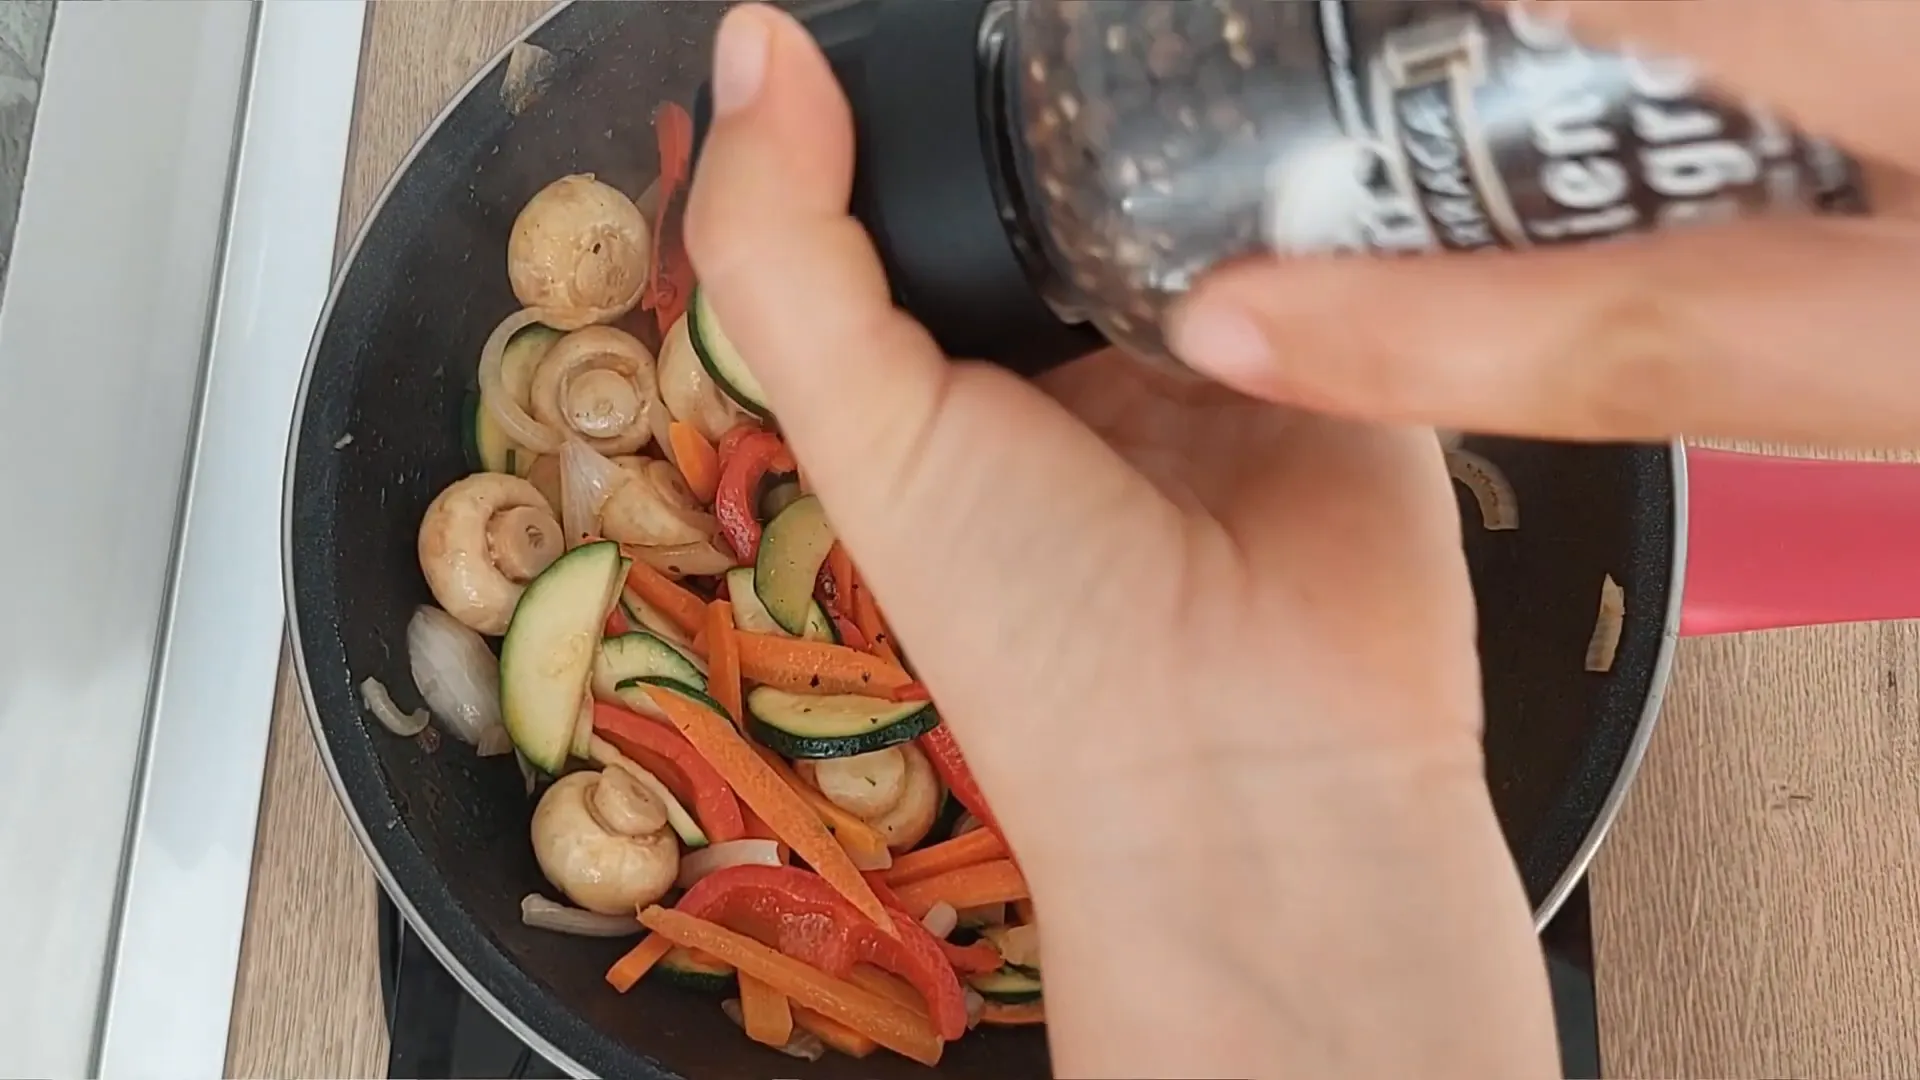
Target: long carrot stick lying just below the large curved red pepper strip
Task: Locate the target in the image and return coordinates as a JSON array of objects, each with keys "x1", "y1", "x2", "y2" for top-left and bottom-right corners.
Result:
[{"x1": 639, "y1": 905, "x2": 943, "y2": 1065}]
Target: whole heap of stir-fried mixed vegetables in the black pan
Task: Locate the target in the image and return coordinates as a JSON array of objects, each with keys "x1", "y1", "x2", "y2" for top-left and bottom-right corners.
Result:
[{"x1": 397, "y1": 155, "x2": 1039, "y2": 1063}]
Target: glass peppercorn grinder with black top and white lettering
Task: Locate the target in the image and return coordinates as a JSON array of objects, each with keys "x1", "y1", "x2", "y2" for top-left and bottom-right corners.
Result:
[{"x1": 695, "y1": 0, "x2": 1864, "y2": 375}]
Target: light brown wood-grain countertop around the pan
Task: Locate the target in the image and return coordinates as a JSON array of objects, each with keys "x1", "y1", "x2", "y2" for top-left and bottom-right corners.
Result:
[{"x1": 227, "y1": 0, "x2": 1920, "y2": 1076}]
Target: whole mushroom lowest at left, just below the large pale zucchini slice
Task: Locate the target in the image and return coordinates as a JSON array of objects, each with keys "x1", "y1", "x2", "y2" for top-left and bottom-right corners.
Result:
[{"x1": 532, "y1": 769, "x2": 680, "y2": 915}]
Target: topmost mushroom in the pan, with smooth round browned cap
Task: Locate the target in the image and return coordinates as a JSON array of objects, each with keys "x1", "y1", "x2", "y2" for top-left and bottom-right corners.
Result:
[{"x1": 507, "y1": 173, "x2": 653, "y2": 331}]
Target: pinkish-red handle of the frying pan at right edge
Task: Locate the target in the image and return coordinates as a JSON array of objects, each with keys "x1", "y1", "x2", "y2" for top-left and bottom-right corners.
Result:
[{"x1": 1680, "y1": 450, "x2": 1920, "y2": 636}]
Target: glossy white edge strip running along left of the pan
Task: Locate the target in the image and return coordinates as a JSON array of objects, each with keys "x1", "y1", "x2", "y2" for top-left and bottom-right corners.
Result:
[{"x1": 54, "y1": 0, "x2": 365, "y2": 1078}]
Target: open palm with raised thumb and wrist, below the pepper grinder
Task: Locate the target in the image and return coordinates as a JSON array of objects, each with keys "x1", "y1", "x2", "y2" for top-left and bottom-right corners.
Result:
[{"x1": 687, "y1": 6, "x2": 1555, "y2": 1076}]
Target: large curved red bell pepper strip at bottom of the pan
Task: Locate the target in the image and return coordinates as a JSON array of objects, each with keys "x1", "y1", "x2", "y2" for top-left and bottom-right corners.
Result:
[{"x1": 674, "y1": 867, "x2": 966, "y2": 1040}]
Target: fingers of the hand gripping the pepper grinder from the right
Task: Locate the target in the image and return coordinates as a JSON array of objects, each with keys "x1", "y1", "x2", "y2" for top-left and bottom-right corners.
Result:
[{"x1": 1171, "y1": 0, "x2": 1920, "y2": 444}]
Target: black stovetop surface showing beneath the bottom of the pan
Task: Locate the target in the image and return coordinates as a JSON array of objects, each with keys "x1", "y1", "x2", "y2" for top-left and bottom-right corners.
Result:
[{"x1": 380, "y1": 886, "x2": 1599, "y2": 1080}]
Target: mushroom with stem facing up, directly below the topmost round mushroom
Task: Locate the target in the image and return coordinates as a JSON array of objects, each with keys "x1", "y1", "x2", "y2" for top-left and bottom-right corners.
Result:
[{"x1": 528, "y1": 327, "x2": 664, "y2": 457}]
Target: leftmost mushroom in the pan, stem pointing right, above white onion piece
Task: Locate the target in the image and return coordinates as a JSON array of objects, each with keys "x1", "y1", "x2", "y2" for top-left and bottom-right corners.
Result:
[{"x1": 419, "y1": 473, "x2": 564, "y2": 634}]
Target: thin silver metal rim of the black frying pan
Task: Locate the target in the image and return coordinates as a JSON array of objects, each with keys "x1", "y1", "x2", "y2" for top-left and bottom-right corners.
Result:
[{"x1": 280, "y1": 0, "x2": 1688, "y2": 1076}]
